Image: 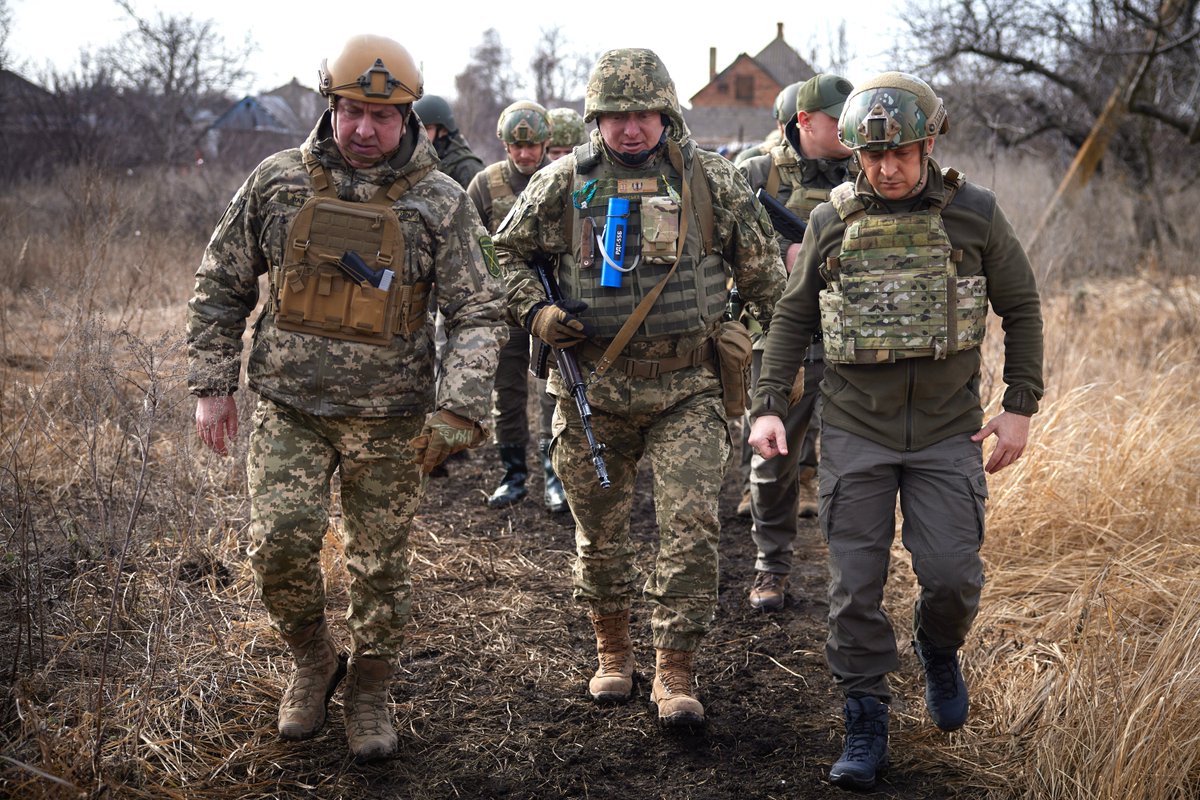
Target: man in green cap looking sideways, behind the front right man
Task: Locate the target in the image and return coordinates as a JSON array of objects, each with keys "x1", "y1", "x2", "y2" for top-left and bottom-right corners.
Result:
[{"x1": 738, "y1": 73, "x2": 853, "y2": 610}]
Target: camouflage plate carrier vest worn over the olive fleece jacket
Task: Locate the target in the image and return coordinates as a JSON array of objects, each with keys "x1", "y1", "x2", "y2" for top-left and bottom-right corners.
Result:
[{"x1": 820, "y1": 169, "x2": 988, "y2": 363}]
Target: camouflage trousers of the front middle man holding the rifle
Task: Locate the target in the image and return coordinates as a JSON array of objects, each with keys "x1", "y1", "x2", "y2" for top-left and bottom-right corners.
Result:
[{"x1": 550, "y1": 357, "x2": 730, "y2": 650}]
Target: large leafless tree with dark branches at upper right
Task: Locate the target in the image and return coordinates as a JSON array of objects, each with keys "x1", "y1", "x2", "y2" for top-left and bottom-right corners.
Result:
[{"x1": 906, "y1": 0, "x2": 1200, "y2": 250}]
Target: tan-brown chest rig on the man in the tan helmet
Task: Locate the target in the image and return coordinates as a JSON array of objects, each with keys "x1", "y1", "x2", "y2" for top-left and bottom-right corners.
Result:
[{"x1": 271, "y1": 154, "x2": 432, "y2": 344}]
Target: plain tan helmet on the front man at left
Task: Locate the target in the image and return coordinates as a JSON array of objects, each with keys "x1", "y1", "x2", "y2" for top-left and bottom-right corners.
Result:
[{"x1": 319, "y1": 34, "x2": 425, "y2": 106}]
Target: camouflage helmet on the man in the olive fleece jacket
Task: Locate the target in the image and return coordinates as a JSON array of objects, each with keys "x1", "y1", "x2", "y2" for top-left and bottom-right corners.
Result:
[{"x1": 838, "y1": 72, "x2": 950, "y2": 150}]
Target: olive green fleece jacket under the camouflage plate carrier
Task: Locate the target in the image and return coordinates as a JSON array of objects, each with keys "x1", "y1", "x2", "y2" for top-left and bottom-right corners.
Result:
[{"x1": 750, "y1": 160, "x2": 1043, "y2": 451}]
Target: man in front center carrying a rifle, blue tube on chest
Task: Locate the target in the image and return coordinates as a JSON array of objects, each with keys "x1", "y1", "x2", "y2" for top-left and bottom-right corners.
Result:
[{"x1": 497, "y1": 49, "x2": 784, "y2": 724}]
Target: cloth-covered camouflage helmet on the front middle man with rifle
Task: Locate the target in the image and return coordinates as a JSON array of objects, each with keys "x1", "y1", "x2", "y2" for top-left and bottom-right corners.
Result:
[{"x1": 583, "y1": 47, "x2": 688, "y2": 139}]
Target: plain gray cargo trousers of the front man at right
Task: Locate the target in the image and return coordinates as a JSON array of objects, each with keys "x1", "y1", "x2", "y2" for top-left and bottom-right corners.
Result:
[{"x1": 818, "y1": 423, "x2": 988, "y2": 702}]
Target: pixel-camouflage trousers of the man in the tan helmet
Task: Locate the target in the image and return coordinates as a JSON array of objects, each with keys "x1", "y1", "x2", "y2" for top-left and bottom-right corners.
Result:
[{"x1": 247, "y1": 398, "x2": 425, "y2": 660}]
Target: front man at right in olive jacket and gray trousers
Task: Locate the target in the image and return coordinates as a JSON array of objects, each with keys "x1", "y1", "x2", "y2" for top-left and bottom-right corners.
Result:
[{"x1": 750, "y1": 72, "x2": 1043, "y2": 788}]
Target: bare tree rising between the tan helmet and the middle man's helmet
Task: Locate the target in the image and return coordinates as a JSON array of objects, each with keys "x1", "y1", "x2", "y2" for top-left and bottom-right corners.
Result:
[{"x1": 454, "y1": 28, "x2": 522, "y2": 162}]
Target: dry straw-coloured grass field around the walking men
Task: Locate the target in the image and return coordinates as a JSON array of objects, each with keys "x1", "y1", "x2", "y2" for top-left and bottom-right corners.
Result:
[{"x1": 0, "y1": 151, "x2": 1200, "y2": 800}]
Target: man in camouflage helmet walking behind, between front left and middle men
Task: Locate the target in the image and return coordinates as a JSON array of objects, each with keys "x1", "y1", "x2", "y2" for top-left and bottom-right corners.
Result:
[{"x1": 467, "y1": 101, "x2": 566, "y2": 513}]
